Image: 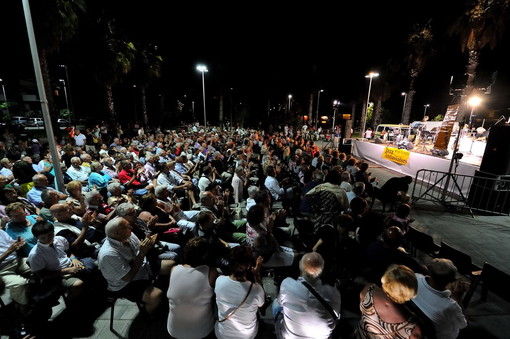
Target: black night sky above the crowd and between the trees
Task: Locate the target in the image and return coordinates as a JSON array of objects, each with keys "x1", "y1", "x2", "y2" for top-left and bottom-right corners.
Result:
[{"x1": 0, "y1": 0, "x2": 508, "y2": 122}]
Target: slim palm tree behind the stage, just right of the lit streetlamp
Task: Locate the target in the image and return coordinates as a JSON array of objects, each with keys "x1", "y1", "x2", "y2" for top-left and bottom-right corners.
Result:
[{"x1": 402, "y1": 22, "x2": 434, "y2": 125}]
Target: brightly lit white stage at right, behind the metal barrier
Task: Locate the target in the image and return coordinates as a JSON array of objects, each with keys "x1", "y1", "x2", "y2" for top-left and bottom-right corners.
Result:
[{"x1": 352, "y1": 138, "x2": 485, "y2": 178}]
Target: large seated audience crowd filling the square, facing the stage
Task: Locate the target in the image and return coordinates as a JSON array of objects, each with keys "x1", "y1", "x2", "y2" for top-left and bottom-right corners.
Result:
[{"x1": 0, "y1": 124, "x2": 467, "y2": 338}]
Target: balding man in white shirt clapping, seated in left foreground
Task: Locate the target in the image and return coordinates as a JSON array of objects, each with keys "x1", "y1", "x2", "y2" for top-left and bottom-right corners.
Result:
[{"x1": 98, "y1": 217, "x2": 175, "y2": 314}]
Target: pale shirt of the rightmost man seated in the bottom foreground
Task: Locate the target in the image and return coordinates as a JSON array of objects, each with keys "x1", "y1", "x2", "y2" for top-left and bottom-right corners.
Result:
[{"x1": 413, "y1": 273, "x2": 467, "y2": 339}]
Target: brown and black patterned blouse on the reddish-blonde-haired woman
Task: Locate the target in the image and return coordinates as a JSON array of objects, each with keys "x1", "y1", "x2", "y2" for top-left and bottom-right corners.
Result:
[{"x1": 356, "y1": 285, "x2": 416, "y2": 339}]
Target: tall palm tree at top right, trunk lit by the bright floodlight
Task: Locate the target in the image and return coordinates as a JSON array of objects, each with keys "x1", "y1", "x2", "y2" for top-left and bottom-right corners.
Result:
[{"x1": 449, "y1": 0, "x2": 510, "y2": 121}]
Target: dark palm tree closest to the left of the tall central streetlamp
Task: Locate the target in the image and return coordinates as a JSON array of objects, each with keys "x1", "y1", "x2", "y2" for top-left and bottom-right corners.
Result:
[{"x1": 133, "y1": 44, "x2": 163, "y2": 125}]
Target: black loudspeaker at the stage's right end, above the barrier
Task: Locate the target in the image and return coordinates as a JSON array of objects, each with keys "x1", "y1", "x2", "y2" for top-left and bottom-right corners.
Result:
[{"x1": 480, "y1": 124, "x2": 510, "y2": 175}]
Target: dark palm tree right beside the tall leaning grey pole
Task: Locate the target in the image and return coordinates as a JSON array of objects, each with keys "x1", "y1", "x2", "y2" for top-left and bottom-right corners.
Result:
[{"x1": 31, "y1": 0, "x2": 87, "y2": 120}]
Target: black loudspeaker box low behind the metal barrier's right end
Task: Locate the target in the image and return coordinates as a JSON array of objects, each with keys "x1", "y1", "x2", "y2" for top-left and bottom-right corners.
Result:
[{"x1": 468, "y1": 171, "x2": 510, "y2": 214}]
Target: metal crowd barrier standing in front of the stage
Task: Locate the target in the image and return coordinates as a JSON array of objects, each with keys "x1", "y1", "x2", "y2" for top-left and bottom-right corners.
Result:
[{"x1": 412, "y1": 169, "x2": 510, "y2": 215}]
